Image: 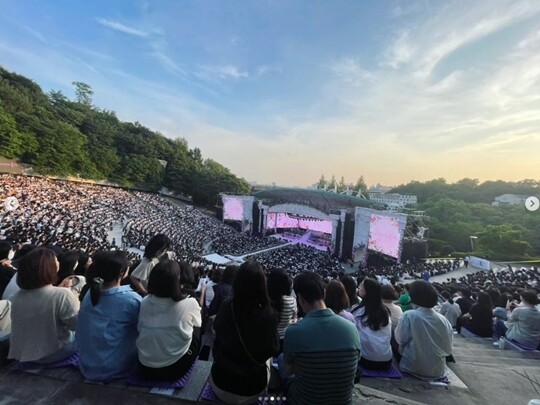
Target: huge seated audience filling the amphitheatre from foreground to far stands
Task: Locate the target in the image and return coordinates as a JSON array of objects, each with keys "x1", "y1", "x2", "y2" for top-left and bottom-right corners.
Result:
[{"x1": 0, "y1": 176, "x2": 540, "y2": 405}]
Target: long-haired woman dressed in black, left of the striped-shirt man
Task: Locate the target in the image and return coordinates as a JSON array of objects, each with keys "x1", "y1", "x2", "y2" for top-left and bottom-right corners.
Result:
[{"x1": 210, "y1": 261, "x2": 279, "y2": 404}]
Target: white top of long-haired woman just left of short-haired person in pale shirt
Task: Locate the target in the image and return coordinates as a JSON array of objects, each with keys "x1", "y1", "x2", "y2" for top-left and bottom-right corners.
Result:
[{"x1": 353, "y1": 307, "x2": 392, "y2": 361}]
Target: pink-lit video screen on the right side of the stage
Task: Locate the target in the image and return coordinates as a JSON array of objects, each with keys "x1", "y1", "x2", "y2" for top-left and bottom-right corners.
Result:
[{"x1": 368, "y1": 214, "x2": 401, "y2": 258}]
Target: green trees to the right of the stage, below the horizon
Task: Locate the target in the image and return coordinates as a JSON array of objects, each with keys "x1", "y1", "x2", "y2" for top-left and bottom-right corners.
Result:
[{"x1": 391, "y1": 179, "x2": 540, "y2": 260}]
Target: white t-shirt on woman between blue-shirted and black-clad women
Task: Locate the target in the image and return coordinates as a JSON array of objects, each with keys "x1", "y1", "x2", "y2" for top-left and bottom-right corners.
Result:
[{"x1": 137, "y1": 295, "x2": 202, "y2": 368}]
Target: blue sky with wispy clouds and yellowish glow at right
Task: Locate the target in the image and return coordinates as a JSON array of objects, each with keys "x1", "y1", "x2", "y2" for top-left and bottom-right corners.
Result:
[{"x1": 0, "y1": 0, "x2": 540, "y2": 186}]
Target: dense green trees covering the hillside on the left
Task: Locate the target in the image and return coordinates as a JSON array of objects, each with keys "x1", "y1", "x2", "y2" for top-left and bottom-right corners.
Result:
[{"x1": 0, "y1": 67, "x2": 249, "y2": 206}]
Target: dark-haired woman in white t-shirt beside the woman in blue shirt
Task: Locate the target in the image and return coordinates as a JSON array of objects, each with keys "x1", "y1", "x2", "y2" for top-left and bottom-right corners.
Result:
[{"x1": 137, "y1": 260, "x2": 202, "y2": 381}]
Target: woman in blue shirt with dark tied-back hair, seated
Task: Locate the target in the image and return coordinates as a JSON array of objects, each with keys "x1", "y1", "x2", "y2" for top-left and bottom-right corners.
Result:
[{"x1": 75, "y1": 251, "x2": 141, "y2": 381}]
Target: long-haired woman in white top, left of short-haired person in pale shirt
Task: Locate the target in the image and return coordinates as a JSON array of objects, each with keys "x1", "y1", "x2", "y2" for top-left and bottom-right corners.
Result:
[{"x1": 352, "y1": 278, "x2": 392, "y2": 370}]
